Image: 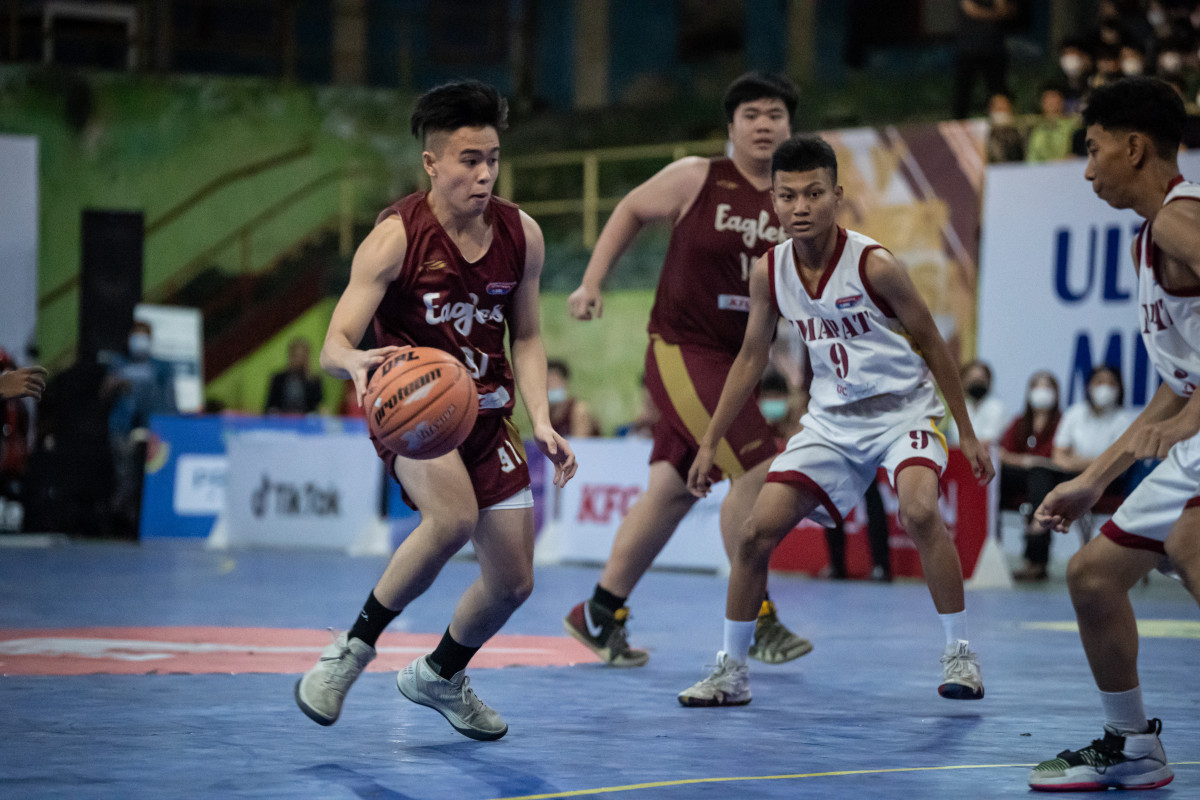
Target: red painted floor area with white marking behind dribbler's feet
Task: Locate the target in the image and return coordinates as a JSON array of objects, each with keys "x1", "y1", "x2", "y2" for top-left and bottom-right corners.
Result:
[{"x1": 0, "y1": 627, "x2": 596, "y2": 675}]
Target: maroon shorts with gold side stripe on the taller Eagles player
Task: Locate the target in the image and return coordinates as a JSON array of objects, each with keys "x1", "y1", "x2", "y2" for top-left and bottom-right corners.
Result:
[{"x1": 646, "y1": 336, "x2": 779, "y2": 481}]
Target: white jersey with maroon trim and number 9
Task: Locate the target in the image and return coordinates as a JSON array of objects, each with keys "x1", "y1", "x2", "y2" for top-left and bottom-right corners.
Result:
[{"x1": 767, "y1": 228, "x2": 931, "y2": 413}]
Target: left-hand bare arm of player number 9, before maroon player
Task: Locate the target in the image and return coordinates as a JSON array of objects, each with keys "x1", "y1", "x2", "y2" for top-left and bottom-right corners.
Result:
[{"x1": 688, "y1": 255, "x2": 779, "y2": 497}]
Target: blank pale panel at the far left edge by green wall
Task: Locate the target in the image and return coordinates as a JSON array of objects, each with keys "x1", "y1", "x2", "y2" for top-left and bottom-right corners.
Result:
[{"x1": 0, "y1": 136, "x2": 37, "y2": 365}]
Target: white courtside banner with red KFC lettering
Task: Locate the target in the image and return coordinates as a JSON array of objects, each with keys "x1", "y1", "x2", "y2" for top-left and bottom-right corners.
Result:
[{"x1": 546, "y1": 439, "x2": 728, "y2": 571}]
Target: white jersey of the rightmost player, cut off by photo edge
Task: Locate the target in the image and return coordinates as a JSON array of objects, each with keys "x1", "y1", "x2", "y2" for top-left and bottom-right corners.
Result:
[{"x1": 1134, "y1": 178, "x2": 1200, "y2": 397}]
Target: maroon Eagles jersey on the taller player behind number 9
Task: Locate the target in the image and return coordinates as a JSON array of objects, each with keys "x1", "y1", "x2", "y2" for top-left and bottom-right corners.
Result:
[{"x1": 649, "y1": 158, "x2": 785, "y2": 355}]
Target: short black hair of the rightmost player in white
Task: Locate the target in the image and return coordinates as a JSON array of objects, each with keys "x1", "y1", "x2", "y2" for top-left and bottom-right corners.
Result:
[{"x1": 1084, "y1": 76, "x2": 1188, "y2": 160}]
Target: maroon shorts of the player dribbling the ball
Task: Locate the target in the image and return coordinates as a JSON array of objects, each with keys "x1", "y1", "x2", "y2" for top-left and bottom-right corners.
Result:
[{"x1": 371, "y1": 414, "x2": 529, "y2": 509}]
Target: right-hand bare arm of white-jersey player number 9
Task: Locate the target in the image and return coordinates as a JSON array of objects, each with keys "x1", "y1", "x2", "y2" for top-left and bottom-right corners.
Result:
[{"x1": 866, "y1": 248, "x2": 996, "y2": 483}]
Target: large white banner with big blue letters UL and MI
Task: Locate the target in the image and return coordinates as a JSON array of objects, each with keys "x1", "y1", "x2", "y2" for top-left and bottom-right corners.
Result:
[{"x1": 978, "y1": 152, "x2": 1200, "y2": 416}]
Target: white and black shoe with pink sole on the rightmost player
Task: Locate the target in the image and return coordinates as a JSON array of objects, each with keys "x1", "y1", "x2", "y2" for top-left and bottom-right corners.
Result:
[{"x1": 1030, "y1": 720, "x2": 1175, "y2": 792}]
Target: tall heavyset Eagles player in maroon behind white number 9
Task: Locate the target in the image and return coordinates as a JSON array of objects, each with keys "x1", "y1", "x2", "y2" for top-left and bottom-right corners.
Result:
[{"x1": 564, "y1": 72, "x2": 812, "y2": 667}]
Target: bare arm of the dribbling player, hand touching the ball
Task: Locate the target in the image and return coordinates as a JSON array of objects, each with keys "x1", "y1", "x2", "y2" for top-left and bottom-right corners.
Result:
[{"x1": 320, "y1": 216, "x2": 407, "y2": 405}]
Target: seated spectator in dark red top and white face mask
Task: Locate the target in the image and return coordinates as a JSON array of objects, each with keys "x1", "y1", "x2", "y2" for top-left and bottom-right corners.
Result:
[{"x1": 1000, "y1": 371, "x2": 1066, "y2": 581}]
